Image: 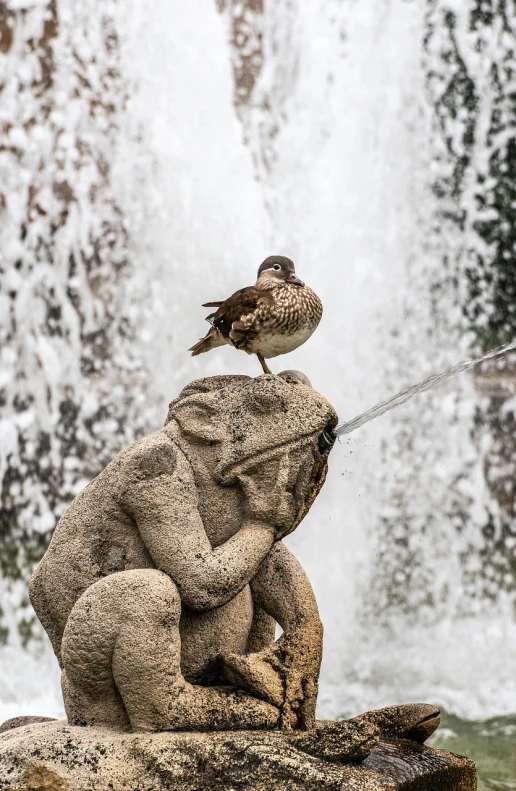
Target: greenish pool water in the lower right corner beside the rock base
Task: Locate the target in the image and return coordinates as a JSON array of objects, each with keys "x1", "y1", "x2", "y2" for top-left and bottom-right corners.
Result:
[{"x1": 428, "y1": 713, "x2": 516, "y2": 791}]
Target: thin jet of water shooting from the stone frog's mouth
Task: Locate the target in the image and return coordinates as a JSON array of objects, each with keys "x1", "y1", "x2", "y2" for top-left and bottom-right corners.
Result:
[{"x1": 326, "y1": 340, "x2": 516, "y2": 447}]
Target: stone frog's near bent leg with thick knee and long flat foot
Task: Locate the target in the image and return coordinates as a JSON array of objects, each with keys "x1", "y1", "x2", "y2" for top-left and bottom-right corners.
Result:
[{"x1": 62, "y1": 569, "x2": 279, "y2": 731}]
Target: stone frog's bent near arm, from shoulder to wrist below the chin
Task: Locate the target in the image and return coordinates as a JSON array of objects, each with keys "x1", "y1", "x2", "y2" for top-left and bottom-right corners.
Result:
[{"x1": 123, "y1": 442, "x2": 274, "y2": 611}]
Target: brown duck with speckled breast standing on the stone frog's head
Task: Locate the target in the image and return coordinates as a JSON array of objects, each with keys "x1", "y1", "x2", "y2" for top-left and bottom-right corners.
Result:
[{"x1": 189, "y1": 255, "x2": 323, "y2": 374}]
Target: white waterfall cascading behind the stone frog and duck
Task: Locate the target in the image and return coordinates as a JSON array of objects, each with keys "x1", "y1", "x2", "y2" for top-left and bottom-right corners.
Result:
[{"x1": 0, "y1": 0, "x2": 516, "y2": 719}]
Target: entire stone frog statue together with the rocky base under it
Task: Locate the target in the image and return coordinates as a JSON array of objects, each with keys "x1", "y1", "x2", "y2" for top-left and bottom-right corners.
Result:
[{"x1": 0, "y1": 371, "x2": 476, "y2": 791}]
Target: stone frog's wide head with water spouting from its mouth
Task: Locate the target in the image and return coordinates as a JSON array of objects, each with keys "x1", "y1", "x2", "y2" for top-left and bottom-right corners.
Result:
[{"x1": 167, "y1": 371, "x2": 337, "y2": 529}]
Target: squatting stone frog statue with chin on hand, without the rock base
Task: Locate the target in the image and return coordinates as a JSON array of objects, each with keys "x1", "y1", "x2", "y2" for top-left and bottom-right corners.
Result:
[{"x1": 29, "y1": 372, "x2": 337, "y2": 731}]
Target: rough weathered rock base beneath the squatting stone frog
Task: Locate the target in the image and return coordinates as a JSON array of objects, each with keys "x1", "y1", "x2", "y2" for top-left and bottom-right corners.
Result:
[{"x1": 0, "y1": 720, "x2": 477, "y2": 791}]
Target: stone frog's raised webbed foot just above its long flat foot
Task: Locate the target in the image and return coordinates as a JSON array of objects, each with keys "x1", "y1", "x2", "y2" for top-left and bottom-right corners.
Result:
[{"x1": 220, "y1": 653, "x2": 285, "y2": 707}]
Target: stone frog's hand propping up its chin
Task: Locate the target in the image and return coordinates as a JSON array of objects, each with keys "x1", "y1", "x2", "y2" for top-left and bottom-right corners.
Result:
[{"x1": 237, "y1": 455, "x2": 298, "y2": 539}]
